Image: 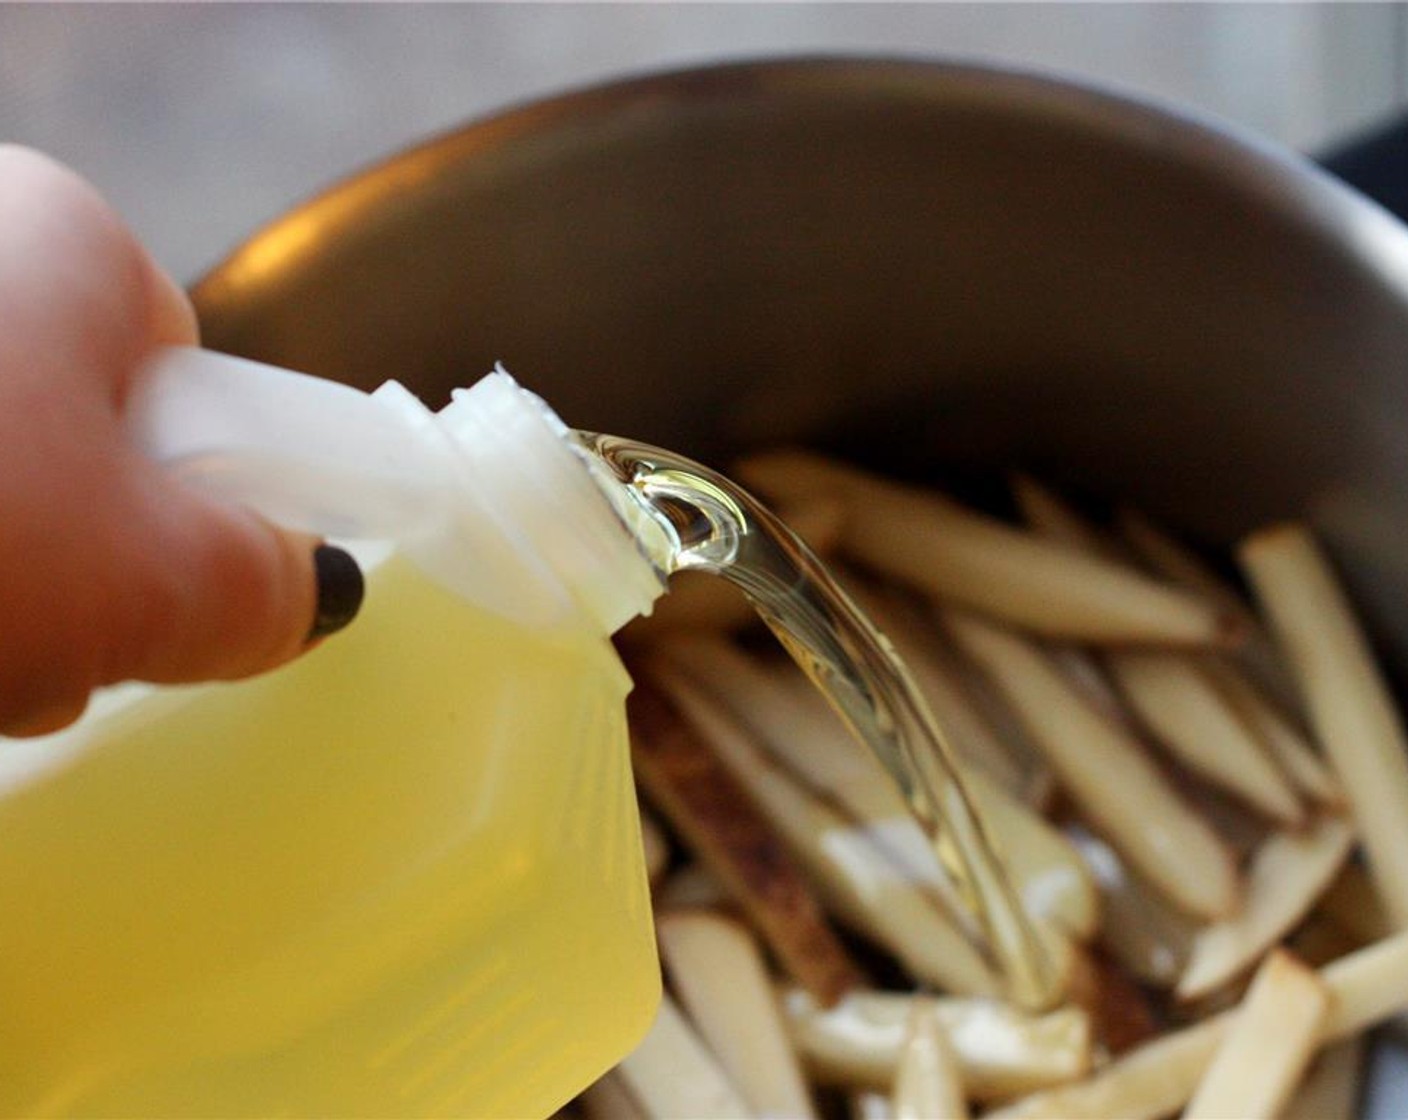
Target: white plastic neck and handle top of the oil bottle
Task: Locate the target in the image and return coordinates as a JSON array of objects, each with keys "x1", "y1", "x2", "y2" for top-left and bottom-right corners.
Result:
[{"x1": 130, "y1": 348, "x2": 665, "y2": 634}]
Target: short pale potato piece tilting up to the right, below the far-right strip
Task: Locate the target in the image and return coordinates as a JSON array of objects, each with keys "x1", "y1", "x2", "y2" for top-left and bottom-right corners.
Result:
[{"x1": 1177, "y1": 817, "x2": 1354, "y2": 999}]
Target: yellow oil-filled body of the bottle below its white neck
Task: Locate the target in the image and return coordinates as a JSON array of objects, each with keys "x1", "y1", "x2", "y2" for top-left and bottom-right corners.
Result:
[{"x1": 0, "y1": 558, "x2": 659, "y2": 1117}]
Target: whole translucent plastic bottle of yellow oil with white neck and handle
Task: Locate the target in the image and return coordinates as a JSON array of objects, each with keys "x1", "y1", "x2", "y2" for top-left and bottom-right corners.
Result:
[{"x1": 0, "y1": 352, "x2": 660, "y2": 1117}]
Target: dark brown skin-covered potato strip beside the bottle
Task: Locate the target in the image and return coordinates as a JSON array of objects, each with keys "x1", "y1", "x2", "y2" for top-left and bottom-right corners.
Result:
[{"x1": 627, "y1": 686, "x2": 859, "y2": 1003}]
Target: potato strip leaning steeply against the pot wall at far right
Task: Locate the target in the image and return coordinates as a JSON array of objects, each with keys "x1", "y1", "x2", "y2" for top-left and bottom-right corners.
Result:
[{"x1": 1239, "y1": 524, "x2": 1408, "y2": 928}]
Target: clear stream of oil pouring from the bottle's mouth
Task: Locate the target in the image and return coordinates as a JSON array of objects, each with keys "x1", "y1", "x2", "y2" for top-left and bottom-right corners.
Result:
[{"x1": 580, "y1": 433, "x2": 1062, "y2": 1010}]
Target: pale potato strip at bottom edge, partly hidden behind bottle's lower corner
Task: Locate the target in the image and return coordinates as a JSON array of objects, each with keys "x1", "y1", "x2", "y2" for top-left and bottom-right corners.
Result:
[{"x1": 617, "y1": 996, "x2": 755, "y2": 1120}]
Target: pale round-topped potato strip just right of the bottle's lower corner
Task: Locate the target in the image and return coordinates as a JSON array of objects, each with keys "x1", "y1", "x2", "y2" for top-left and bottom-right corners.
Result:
[{"x1": 656, "y1": 910, "x2": 815, "y2": 1120}]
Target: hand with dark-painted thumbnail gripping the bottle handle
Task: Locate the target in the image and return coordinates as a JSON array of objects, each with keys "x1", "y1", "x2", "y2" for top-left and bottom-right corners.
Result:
[{"x1": 0, "y1": 145, "x2": 362, "y2": 735}]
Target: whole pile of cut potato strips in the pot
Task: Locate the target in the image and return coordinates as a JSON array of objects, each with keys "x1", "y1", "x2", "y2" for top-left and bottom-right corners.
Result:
[{"x1": 562, "y1": 451, "x2": 1408, "y2": 1120}]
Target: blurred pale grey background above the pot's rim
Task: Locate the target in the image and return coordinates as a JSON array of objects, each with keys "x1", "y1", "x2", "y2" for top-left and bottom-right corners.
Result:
[{"x1": 8, "y1": 3, "x2": 1408, "y2": 282}]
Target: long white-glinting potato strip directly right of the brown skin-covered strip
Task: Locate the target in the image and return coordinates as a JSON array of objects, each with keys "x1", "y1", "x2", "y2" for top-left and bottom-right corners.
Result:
[{"x1": 649, "y1": 662, "x2": 1001, "y2": 995}]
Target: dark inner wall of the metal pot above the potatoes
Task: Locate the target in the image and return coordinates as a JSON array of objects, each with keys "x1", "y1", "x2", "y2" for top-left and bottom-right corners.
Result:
[{"x1": 196, "y1": 61, "x2": 1408, "y2": 684}]
